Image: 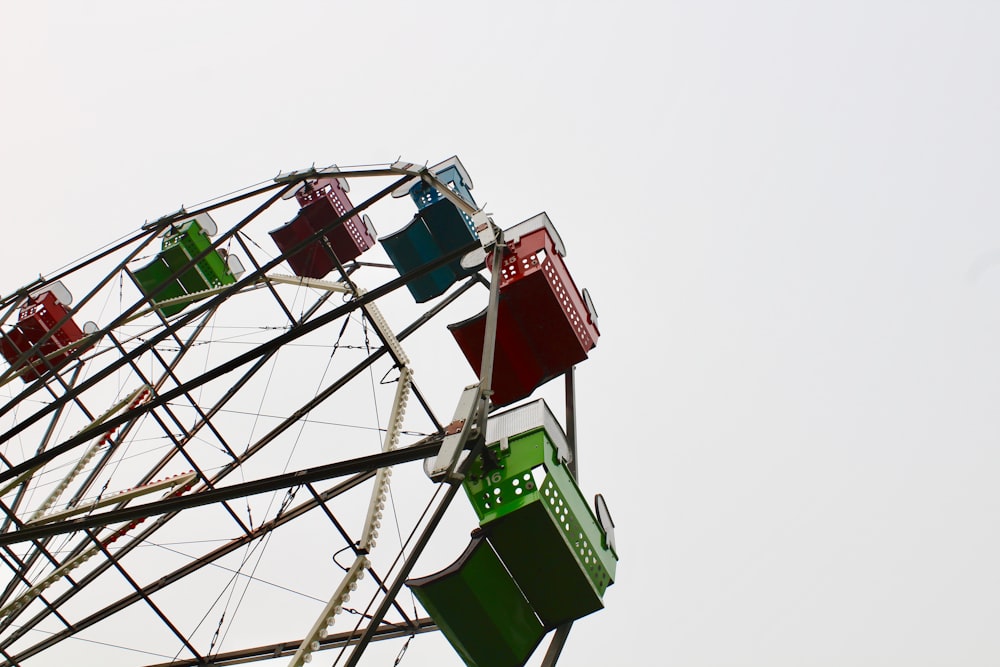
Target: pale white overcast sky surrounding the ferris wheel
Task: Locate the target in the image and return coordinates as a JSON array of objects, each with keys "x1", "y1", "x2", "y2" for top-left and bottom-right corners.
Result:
[{"x1": 0, "y1": 0, "x2": 1000, "y2": 667}]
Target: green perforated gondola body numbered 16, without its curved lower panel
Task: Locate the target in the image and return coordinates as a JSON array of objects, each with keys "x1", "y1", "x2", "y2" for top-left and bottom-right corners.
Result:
[{"x1": 464, "y1": 428, "x2": 618, "y2": 628}]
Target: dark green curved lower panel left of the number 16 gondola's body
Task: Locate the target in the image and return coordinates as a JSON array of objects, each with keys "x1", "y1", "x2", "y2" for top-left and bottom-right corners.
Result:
[{"x1": 406, "y1": 537, "x2": 545, "y2": 667}]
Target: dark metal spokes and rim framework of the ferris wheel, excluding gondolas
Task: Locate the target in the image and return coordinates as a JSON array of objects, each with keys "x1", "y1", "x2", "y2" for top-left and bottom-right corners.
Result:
[{"x1": 0, "y1": 163, "x2": 588, "y2": 667}]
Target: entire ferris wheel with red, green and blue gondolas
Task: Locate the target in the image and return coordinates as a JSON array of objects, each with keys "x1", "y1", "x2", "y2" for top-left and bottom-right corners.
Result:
[{"x1": 0, "y1": 157, "x2": 618, "y2": 667}]
